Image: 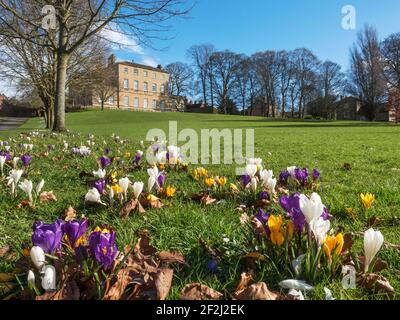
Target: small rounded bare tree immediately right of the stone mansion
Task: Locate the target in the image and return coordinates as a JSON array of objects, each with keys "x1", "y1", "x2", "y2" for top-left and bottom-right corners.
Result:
[{"x1": 165, "y1": 62, "x2": 193, "y2": 96}]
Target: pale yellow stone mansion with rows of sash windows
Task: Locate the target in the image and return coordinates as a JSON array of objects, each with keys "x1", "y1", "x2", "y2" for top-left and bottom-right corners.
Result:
[{"x1": 92, "y1": 57, "x2": 175, "y2": 111}]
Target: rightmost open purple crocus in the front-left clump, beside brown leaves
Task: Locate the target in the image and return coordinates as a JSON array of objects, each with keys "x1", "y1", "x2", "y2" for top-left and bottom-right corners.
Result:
[{"x1": 89, "y1": 230, "x2": 118, "y2": 270}]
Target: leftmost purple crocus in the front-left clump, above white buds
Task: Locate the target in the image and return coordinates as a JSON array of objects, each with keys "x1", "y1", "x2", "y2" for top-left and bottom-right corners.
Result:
[{"x1": 32, "y1": 219, "x2": 64, "y2": 254}]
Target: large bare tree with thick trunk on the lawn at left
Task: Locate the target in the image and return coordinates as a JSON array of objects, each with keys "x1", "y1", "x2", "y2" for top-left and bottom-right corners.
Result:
[{"x1": 0, "y1": 0, "x2": 192, "y2": 131}]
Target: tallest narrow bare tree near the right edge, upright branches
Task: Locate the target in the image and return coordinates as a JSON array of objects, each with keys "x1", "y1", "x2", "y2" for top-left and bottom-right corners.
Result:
[{"x1": 350, "y1": 25, "x2": 386, "y2": 120}]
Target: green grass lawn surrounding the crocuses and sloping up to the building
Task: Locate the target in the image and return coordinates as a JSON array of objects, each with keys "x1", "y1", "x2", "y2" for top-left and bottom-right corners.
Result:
[{"x1": 0, "y1": 111, "x2": 400, "y2": 299}]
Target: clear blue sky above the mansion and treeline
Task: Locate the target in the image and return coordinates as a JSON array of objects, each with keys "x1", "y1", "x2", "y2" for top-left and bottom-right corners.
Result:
[{"x1": 117, "y1": 0, "x2": 400, "y2": 68}]
